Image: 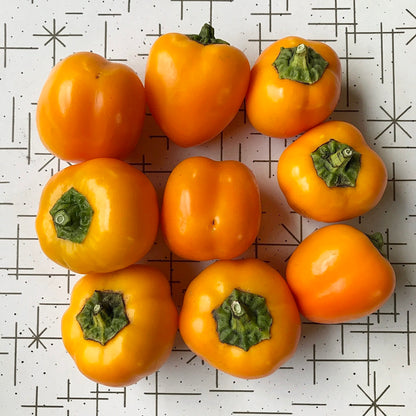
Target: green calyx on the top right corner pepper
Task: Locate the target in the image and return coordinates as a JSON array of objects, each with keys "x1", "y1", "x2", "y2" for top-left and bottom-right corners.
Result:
[{"x1": 272, "y1": 43, "x2": 328, "y2": 85}]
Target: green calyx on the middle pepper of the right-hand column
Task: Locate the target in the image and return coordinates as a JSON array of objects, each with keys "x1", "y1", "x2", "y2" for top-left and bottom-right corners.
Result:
[{"x1": 311, "y1": 139, "x2": 361, "y2": 188}]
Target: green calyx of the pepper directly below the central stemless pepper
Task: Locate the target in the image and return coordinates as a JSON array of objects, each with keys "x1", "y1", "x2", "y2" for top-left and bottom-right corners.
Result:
[{"x1": 212, "y1": 289, "x2": 272, "y2": 351}]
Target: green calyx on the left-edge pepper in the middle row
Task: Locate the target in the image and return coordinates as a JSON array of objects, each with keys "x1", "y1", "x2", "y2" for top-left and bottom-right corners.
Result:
[{"x1": 49, "y1": 188, "x2": 94, "y2": 243}]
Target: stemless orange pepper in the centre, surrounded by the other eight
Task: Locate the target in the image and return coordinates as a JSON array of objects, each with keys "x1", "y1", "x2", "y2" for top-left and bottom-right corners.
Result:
[{"x1": 161, "y1": 157, "x2": 261, "y2": 260}]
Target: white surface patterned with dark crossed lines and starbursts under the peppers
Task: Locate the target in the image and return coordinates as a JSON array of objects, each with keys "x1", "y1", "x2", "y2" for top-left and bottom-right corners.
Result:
[{"x1": 0, "y1": 0, "x2": 416, "y2": 416}]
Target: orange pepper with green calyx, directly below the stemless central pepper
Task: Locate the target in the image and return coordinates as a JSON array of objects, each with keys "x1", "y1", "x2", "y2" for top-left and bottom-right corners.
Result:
[{"x1": 179, "y1": 259, "x2": 301, "y2": 379}]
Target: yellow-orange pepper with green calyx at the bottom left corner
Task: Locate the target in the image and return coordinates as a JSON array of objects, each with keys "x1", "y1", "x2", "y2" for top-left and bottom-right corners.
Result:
[{"x1": 61, "y1": 265, "x2": 178, "y2": 386}]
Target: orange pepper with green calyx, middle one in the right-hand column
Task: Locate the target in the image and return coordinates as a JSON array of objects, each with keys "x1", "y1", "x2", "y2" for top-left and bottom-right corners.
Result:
[{"x1": 277, "y1": 121, "x2": 387, "y2": 222}]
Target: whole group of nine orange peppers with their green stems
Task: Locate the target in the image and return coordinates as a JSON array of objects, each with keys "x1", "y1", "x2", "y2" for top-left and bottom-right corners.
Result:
[{"x1": 36, "y1": 24, "x2": 395, "y2": 386}]
